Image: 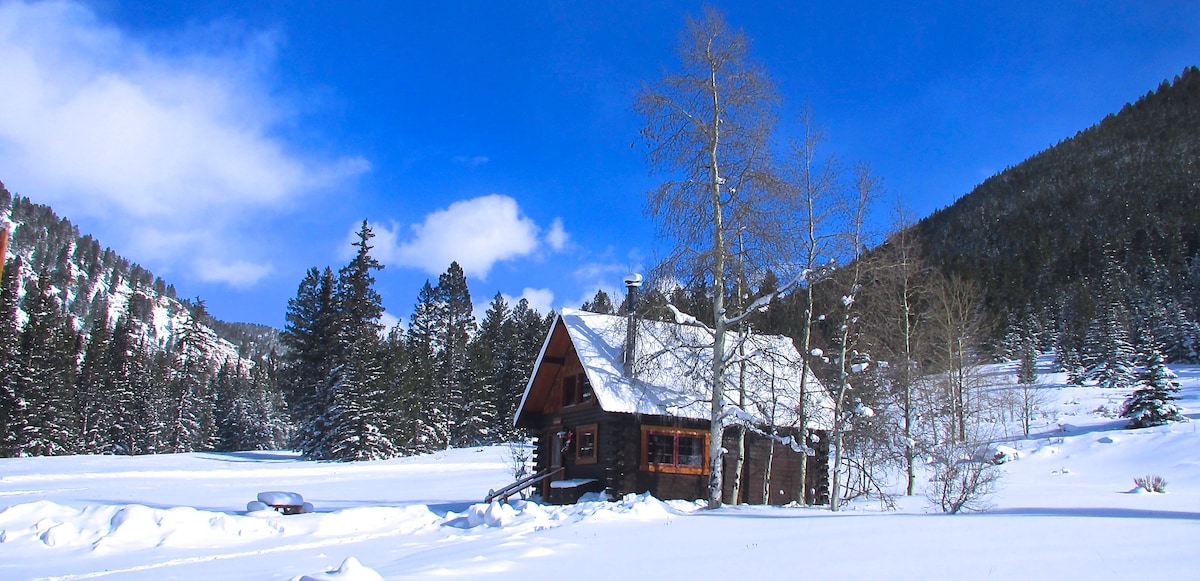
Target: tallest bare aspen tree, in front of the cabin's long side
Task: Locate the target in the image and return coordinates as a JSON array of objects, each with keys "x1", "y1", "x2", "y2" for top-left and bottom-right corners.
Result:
[{"x1": 635, "y1": 8, "x2": 796, "y2": 508}]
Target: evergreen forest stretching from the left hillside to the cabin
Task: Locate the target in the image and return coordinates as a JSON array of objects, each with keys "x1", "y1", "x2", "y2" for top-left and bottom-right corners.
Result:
[{"x1": 0, "y1": 185, "x2": 550, "y2": 460}]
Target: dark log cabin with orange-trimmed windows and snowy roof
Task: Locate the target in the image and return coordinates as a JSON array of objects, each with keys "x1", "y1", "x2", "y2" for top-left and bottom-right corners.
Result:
[{"x1": 514, "y1": 303, "x2": 832, "y2": 504}]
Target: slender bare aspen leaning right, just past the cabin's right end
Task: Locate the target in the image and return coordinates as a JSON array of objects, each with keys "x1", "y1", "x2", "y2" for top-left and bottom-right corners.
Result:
[{"x1": 829, "y1": 163, "x2": 880, "y2": 510}]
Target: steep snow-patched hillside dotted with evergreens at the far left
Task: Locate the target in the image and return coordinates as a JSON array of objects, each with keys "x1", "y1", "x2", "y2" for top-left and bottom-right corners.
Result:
[{"x1": 0, "y1": 185, "x2": 289, "y2": 456}]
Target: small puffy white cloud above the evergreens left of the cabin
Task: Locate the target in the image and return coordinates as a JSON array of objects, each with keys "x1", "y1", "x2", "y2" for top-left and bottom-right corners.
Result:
[{"x1": 372, "y1": 194, "x2": 539, "y2": 278}]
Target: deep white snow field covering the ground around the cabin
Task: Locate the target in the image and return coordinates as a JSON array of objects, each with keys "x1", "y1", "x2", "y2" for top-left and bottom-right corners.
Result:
[{"x1": 0, "y1": 360, "x2": 1200, "y2": 581}]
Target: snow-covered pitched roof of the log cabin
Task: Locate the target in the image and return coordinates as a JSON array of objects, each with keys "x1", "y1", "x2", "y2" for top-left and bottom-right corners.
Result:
[{"x1": 517, "y1": 310, "x2": 832, "y2": 429}]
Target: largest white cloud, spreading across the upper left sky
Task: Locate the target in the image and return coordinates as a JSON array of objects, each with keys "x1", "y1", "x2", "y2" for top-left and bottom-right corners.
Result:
[{"x1": 0, "y1": 2, "x2": 370, "y2": 284}]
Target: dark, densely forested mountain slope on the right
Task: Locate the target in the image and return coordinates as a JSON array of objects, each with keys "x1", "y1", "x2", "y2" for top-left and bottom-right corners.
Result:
[{"x1": 914, "y1": 67, "x2": 1200, "y2": 360}]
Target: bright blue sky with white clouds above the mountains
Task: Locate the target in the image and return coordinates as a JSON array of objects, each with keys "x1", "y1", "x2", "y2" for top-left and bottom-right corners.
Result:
[{"x1": 0, "y1": 0, "x2": 1200, "y2": 327}]
